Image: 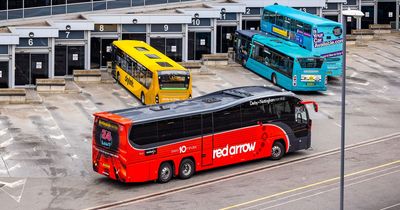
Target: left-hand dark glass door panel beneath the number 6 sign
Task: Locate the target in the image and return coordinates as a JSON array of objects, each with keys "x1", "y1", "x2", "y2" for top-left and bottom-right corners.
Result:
[{"x1": 15, "y1": 53, "x2": 30, "y2": 85}]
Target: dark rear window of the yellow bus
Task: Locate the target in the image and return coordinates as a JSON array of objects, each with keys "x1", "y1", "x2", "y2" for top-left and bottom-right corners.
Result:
[{"x1": 158, "y1": 71, "x2": 190, "y2": 90}]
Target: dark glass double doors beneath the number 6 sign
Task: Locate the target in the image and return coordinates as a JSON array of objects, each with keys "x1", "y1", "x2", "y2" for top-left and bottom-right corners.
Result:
[{"x1": 15, "y1": 53, "x2": 49, "y2": 85}]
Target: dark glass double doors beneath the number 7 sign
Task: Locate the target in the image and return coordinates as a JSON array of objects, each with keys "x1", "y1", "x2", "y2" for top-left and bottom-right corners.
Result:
[{"x1": 54, "y1": 46, "x2": 85, "y2": 76}]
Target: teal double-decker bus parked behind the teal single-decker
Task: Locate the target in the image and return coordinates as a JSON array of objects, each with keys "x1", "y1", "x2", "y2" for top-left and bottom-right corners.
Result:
[{"x1": 261, "y1": 4, "x2": 343, "y2": 77}]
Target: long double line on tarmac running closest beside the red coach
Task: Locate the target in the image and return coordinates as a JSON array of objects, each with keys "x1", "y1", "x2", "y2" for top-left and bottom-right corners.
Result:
[{"x1": 86, "y1": 132, "x2": 400, "y2": 210}]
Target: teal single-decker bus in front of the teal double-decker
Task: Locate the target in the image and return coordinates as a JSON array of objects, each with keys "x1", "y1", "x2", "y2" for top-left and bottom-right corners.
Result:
[{"x1": 235, "y1": 30, "x2": 327, "y2": 91}]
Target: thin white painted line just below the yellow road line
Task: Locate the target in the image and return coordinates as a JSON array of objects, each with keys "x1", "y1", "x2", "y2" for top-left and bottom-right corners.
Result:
[{"x1": 241, "y1": 165, "x2": 400, "y2": 210}]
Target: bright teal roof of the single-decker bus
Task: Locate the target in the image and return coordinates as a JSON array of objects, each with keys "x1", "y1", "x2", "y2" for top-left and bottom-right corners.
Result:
[{"x1": 253, "y1": 35, "x2": 319, "y2": 58}]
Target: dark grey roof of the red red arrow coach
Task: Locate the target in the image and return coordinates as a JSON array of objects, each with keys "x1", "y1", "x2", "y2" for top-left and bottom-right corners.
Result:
[{"x1": 110, "y1": 86, "x2": 294, "y2": 123}]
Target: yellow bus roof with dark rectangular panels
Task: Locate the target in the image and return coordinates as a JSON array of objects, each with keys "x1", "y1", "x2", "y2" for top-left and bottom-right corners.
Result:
[{"x1": 113, "y1": 40, "x2": 186, "y2": 71}]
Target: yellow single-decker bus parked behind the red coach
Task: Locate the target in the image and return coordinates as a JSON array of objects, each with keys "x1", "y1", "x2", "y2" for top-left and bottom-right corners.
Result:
[{"x1": 112, "y1": 40, "x2": 192, "y2": 104}]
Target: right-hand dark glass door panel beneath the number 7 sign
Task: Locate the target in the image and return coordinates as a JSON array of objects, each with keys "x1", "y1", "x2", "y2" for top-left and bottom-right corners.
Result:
[{"x1": 67, "y1": 46, "x2": 85, "y2": 75}]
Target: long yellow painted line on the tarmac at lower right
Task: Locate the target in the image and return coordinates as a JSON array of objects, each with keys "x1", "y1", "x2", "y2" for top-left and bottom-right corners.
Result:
[{"x1": 221, "y1": 160, "x2": 400, "y2": 210}]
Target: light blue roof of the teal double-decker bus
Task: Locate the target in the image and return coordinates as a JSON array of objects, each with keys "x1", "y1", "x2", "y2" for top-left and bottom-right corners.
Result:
[{"x1": 264, "y1": 4, "x2": 342, "y2": 27}]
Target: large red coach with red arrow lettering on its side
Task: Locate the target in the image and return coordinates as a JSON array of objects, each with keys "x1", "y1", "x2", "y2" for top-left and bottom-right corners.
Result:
[{"x1": 92, "y1": 86, "x2": 318, "y2": 183}]
